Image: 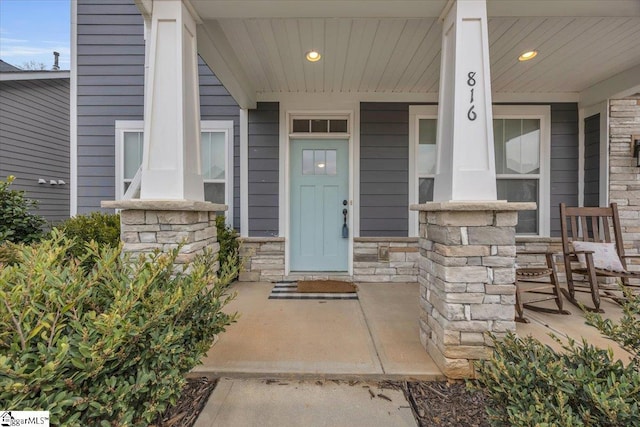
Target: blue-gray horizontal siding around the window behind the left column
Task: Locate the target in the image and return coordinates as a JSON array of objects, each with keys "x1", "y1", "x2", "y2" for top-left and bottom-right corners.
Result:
[{"x1": 77, "y1": 0, "x2": 240, "y2": 228}]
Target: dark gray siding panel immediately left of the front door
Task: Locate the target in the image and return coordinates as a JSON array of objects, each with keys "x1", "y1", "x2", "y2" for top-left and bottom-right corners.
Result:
[{"x1": 248, "y1": 102, "x2": 280, "y2": 237}]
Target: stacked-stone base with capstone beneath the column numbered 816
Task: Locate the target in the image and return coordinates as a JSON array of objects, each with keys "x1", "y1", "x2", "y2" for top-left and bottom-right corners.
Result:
[{"x1": 411, "y1": 202, "x2": 535, "y2": 378}]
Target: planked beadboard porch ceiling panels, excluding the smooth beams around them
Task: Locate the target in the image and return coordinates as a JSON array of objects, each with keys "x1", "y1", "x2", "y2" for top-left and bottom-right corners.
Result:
[{"x1": 198, "y1": 17, "x2": 640, "y2": 93}]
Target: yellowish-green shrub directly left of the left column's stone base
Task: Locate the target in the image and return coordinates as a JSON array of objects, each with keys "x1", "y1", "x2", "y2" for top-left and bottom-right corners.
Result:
[{"x1": 56, "y1": 212, "x2": 120, "y2": 257}]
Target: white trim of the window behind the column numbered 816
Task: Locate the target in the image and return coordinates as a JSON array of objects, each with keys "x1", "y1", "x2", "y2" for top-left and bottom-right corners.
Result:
[{"x1": 409, "y1": 105, "x2": 551, "y2": 237}]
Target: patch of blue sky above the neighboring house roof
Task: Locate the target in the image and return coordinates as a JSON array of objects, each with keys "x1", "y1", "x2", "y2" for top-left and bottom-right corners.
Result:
[{"x1": 0, "y1": 0, "x2": 71, "y2": 70}]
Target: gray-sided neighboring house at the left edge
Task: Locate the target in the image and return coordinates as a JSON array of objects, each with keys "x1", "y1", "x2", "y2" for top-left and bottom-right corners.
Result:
[{"x1": 0, "y1": 61, "x2": 71, "y2": 227}]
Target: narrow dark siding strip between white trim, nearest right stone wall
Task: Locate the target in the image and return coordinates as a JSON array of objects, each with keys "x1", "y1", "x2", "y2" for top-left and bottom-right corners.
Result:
[{"x1": 584, "y1": 114, "x2": 600, "y2": 206}]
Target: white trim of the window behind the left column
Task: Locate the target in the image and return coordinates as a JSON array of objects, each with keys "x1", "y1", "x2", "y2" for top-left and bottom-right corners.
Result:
[{"x1": 115, "y1": 120, "x2": 234, "y2": 225}]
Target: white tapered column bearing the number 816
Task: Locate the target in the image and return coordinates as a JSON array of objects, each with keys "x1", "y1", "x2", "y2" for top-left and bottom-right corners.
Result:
[{"x1": 433, "y1": 0, "x2": 497, "y2": 202}]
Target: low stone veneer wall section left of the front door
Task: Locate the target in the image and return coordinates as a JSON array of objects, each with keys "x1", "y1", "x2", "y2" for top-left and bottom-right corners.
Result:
[{"x1": 238, "y1": 237, "x2": 284, "y2": 282}]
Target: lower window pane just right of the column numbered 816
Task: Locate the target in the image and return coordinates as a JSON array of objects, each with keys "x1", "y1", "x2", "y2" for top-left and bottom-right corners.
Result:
[{"x1": 496, "y1": 179, "x2": 538, "y2": 234}]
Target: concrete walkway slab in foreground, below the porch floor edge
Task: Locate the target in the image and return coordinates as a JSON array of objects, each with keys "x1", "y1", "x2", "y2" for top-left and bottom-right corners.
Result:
[{"x1": 195, "y1": 379, "x2": 417, "y2": 427}]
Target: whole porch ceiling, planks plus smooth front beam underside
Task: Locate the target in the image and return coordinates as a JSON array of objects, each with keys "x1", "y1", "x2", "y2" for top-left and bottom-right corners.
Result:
[{"x1": 192, "y1": 0, "x2": 640, "y2": 106}]
